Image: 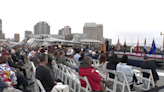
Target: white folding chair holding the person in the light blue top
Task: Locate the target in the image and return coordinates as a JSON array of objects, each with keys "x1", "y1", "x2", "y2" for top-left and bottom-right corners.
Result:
[{"x1": 115, "y1": 71, "x2": 132, "y2": 92}]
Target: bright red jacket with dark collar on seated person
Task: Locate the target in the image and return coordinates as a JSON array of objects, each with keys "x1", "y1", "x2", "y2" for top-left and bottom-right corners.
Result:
[{"x1": 79, "y1": 61, "x2": 101, "y2": 91}]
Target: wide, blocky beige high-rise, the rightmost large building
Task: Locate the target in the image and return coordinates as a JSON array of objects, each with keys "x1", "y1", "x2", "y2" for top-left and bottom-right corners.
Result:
[{"x1": 83, "y1": 23, "x2": 104, "y2": 42}]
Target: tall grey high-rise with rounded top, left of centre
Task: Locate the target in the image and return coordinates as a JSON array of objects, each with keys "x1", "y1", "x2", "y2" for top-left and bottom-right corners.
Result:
[{"x1": 34, "y1": 21, "x2": 50, "y2": 34}]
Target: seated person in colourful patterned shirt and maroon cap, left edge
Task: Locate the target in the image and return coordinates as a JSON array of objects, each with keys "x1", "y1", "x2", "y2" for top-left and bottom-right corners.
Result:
[{"x1": 0, "y1": 53, "x2": 34, "y2": 92}]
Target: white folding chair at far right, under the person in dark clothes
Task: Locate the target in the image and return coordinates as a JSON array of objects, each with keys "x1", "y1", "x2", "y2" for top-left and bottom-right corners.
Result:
[{"x1": 140, "y1": 69, "x2": 155, "y2": 90}]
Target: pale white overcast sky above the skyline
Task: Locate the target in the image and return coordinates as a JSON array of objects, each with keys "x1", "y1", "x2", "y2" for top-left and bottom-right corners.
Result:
[{"x1": 0, "y1": 0, "x2": 164, "y2": 46}]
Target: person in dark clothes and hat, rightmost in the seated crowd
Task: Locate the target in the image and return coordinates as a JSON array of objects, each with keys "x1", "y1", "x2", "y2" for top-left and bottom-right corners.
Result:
[{"x1": 141, "y1": 55, "x2": 159, "y2": 84}]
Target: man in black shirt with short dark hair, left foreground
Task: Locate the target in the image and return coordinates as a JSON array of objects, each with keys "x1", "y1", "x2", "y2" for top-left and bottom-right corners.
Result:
[{"x1": 36, "y1": 53, "x2": 57, "y2": 92}]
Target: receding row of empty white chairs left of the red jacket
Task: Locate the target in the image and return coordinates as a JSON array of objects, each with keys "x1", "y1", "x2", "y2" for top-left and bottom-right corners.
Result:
[{"x1": 54, "y1": 63, "x2": 92, "y2": 92}]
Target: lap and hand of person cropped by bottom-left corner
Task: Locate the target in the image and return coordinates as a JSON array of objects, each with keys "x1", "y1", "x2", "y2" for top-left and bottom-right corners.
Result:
[{"x1": 0, "y1": 78, "x2": 21, "y2": 92}]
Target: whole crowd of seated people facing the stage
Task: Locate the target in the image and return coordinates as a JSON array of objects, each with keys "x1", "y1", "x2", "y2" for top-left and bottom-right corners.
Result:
[{"x1": 0, "y1": 46, "x2": 159, "y2": 92}]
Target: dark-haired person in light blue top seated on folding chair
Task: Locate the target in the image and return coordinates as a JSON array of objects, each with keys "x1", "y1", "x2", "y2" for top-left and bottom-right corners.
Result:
[{"x1": 116, "y1": 55, "x2": 142, "y2": 91}]
